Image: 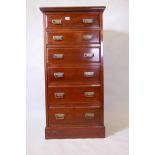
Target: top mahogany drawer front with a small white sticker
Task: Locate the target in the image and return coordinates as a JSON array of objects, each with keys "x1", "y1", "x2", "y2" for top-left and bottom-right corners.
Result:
[{"x1": 46, "y1": 12, "x2": 100, "y2": 29}]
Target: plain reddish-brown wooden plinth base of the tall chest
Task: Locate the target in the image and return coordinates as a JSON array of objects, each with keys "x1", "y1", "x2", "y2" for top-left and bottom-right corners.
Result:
[{"x1": 45, "y1": 125, "x2": 105, "y2": 139}]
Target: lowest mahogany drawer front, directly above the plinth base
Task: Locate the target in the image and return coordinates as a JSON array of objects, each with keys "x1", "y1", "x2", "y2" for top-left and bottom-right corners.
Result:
[{"x1": 49, "y1": 107, "x2": 101, "y2": 126}]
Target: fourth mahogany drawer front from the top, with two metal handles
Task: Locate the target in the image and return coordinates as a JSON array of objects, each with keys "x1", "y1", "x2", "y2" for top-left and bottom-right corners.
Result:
[{"x1": 48, "y1": 66, "x2": 100, "y2": 84}]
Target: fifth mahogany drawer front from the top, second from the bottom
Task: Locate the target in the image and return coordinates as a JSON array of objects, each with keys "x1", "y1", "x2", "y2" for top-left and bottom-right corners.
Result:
[{"x1": 48, "y1": 86, "x2": 101, "y2": 105}]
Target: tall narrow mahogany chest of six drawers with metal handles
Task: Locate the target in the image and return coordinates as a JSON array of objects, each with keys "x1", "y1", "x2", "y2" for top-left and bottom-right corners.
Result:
[{"x1": 40, "y1": 7, "x2": 105, "y2": 139}]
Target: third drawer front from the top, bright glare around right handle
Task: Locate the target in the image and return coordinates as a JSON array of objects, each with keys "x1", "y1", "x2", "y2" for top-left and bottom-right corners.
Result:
[{"x1": 47, "y1": 48, "x2": 100, "y2": 64}]
